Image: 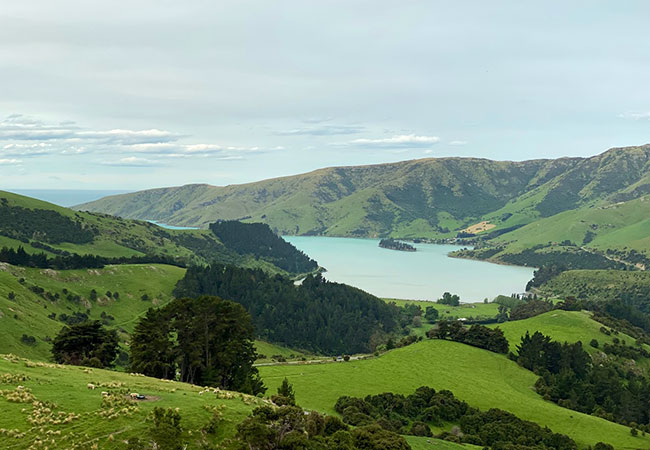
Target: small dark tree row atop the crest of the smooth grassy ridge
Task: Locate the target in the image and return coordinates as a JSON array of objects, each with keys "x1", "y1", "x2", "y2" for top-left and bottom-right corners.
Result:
[{"x1": 427, "y1": 320, "x2": 509, "y2": 353}]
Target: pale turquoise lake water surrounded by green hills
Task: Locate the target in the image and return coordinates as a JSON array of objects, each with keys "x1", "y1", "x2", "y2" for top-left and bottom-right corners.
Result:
[{"x1": 285, "y1": 236, "x2": 533, "y2": 302}]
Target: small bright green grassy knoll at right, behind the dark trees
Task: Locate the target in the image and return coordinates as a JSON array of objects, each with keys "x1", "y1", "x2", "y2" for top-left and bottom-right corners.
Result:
[{"x1": 490, "y1": 310, "x2": 650, "y2": 353}]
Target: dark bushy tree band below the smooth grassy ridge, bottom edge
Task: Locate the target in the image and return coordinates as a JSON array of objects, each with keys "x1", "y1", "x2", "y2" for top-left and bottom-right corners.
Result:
[{"x1": 334, "y1": 386, "x2": 577, "y2": 450}]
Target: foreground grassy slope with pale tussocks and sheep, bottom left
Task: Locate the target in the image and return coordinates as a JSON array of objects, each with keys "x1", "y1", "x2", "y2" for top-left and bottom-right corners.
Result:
[{"x1": 0, "y1": 355, "x2": 262, "y2": 449}]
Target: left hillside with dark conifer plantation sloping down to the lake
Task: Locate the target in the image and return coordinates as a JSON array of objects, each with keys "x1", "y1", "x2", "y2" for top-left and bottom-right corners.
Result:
[{"x1": 0, "y1": 191, "x2": 318, "y2": 274}]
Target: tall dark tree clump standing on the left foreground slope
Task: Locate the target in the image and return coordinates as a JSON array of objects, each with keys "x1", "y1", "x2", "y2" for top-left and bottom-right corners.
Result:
[{"x1": 130, "y1": 296, "x2": 266, "y2": 394}]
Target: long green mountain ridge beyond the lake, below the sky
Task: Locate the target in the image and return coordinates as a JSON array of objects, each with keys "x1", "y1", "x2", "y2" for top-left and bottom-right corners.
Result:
[{"x1": 77, "y1": 145, "x2": 650, "y2": 260}]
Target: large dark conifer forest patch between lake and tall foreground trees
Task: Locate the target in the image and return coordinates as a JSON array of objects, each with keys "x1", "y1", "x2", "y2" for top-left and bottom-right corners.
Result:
[{"x1": 174, "y1": 264, "x2": 400, "y2": 355}]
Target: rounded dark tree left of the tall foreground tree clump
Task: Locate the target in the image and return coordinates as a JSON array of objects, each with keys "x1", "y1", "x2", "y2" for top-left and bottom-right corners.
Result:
[{"x1": 52, "y1": 320, "x2": 118, "y2": 368}]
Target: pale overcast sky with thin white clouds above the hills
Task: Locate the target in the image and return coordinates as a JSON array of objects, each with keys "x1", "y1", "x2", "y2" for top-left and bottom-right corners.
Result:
[{"x1": 0, "y1": 0, "x2": 650, "y2": 190}]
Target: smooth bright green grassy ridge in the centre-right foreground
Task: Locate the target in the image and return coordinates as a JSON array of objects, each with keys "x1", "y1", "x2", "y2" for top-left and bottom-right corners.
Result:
[{"x1": 260, "y1": 340, "x2": 650, "y2": 449}]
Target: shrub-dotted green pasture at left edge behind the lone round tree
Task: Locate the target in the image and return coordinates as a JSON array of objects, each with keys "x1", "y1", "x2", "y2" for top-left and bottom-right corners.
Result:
[{"x1": 0, "y1": 264, "x2": 185, "y2": 360}]
